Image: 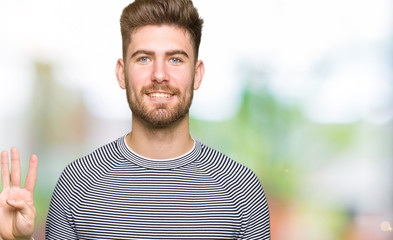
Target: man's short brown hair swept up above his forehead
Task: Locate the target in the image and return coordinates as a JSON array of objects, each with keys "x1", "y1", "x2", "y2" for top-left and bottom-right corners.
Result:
[{"x1": 120, "y1": 0, "x2": 203, "y2": 60}]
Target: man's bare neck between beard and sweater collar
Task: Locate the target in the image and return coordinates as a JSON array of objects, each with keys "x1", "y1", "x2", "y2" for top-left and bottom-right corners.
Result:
[{"x1": 126, "y1": 114, "x2": 194, "y2": 160}]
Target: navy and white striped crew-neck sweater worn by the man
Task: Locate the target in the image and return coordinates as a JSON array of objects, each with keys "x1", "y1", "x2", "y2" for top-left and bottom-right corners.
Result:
[{"x1": 46, "y1": 137, "x2": 270, "y2": 239}]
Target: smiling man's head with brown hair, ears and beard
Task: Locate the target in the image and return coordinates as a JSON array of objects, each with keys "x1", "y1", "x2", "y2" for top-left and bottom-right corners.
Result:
[{"x1": 116, "y1": 0, "x2": 204, "y2": 128}]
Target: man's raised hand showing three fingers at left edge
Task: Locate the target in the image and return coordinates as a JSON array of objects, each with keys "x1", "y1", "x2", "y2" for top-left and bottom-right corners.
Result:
[{"x1": 0, "y1": 147, "x2": 38, "y2": 240}]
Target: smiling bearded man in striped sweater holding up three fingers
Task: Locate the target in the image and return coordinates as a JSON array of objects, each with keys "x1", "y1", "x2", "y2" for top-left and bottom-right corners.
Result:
[{"x1": 2, "y1": 0, "x2": 270, "y2": 239}]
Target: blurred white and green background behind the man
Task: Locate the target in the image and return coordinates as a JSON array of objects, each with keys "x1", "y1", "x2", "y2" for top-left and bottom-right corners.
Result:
[{"x1": 0, "y1": 0, "x2": 393, "y2": 240}]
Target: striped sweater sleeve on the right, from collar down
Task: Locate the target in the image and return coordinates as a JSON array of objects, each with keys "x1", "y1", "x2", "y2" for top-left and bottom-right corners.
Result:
[{"x1": 201, "y1": 146, "x2": 270, "y2": 240}]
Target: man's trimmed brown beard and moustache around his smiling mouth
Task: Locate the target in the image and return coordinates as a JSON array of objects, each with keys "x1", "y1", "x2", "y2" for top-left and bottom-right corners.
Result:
[{"x1": 126, "y1": 78, "x2": 194, "y2": 128}]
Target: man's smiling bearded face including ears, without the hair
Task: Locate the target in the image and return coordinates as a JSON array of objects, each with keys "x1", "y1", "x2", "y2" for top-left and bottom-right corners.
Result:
[{"x1": 116, "y1": 25, "x2": 204, "y2": 127}]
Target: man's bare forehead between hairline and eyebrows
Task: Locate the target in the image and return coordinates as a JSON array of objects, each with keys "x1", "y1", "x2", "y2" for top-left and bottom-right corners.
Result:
[{"x1": 128, "y1": 25, "x2": 194, "y2": 57}]
